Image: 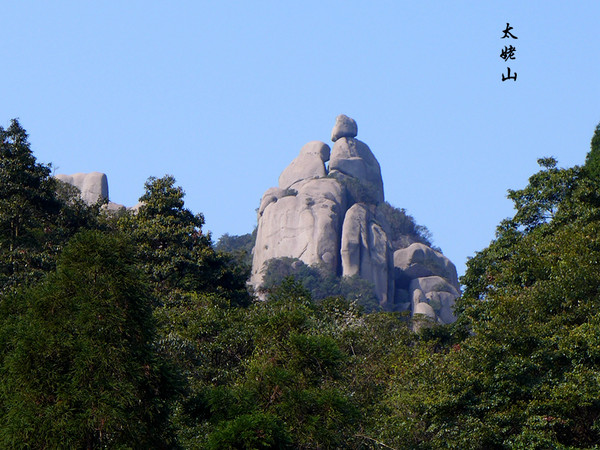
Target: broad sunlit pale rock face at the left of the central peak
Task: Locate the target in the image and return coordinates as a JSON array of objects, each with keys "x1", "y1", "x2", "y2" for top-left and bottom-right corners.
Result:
[{"x1": 251, "y1": 178, "x2": 346, "y2": 286}]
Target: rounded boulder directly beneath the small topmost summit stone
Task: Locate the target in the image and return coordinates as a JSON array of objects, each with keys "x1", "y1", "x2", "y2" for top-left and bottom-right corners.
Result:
[{"x1": 329, "y1": 137, "x2": 384, "y2": 202}]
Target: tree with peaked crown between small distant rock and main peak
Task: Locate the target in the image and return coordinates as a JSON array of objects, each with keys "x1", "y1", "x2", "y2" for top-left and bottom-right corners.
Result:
[{"x1": 120, "y1": 175, "x2": 250, "y2": 305}]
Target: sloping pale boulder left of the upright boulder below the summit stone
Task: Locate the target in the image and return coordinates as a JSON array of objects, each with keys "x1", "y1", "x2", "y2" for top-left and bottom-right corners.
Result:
[{"x1": 279, "y1": 141, "x2": 330, "y2": 189}]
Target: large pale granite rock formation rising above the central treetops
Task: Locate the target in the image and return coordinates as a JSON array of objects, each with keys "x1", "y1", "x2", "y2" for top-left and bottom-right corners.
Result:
[{"x1": 251, "y1": 115, "x2": 460, "y2": 323}]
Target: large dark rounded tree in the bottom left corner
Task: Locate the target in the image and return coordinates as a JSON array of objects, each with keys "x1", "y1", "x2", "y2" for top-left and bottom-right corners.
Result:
[{"x1": 0, "y1": 231, "x2": 176, "y2": 448}]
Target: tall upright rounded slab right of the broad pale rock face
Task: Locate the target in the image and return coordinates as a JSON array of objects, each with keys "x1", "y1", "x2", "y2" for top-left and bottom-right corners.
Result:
[{"x1": 341, "y1": 203, "x2": 394, "y2": 306}]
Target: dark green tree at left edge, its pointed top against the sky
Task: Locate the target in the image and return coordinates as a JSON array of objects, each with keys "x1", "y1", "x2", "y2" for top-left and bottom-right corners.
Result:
[{"x1": 0, "y1": 119, "x2": 100, "y2": 293}]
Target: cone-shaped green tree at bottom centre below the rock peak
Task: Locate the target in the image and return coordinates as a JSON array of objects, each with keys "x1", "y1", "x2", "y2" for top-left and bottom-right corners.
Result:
[{"x1": 199, "y1": 279, "x2": 359, "y2": 448}]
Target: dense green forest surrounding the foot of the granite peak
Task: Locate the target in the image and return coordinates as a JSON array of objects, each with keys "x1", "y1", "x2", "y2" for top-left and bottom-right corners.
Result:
[{"x1": 0, "y1": 120, "x2": 600, "y2": 449}]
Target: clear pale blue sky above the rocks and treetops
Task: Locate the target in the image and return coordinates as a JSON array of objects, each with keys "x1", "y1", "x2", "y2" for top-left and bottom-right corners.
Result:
[{"x1": 0, "y1": 0, "x2": 600, "y2": 274}]
